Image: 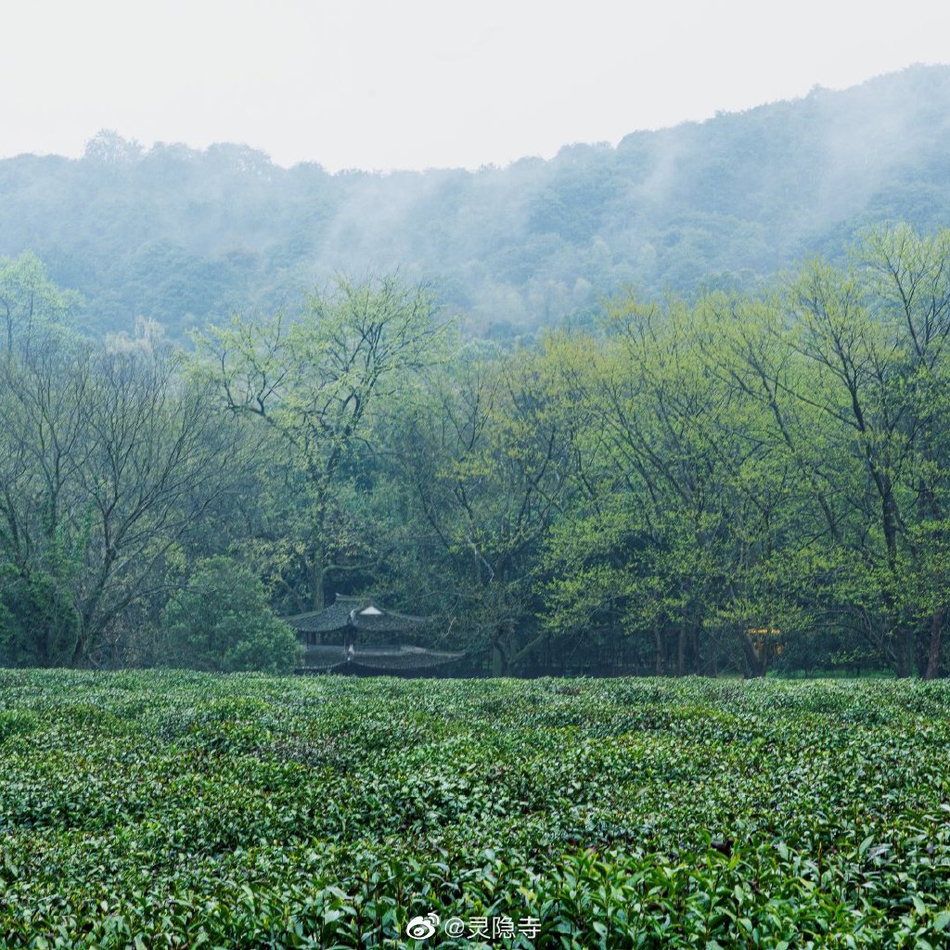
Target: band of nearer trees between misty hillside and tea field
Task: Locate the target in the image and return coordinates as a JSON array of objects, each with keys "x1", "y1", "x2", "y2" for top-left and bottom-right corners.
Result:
[{"x1": 0, "y1": 224, "x2": 950, "y2": 679}]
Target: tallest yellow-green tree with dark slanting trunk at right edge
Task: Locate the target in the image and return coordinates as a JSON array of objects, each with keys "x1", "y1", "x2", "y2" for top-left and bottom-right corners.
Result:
[{"x1": 700, "y1": 227, "x2": 950, "y2": 678}]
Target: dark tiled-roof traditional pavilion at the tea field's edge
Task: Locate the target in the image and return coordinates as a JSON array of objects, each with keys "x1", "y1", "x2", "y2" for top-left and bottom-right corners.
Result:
[{"x1": 284, "y1": 594, "x2": 465, "y2": 676}]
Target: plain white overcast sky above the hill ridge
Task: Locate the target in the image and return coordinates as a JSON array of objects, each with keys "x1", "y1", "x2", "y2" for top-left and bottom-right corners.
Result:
[{"x1": 0, "y1": 0, "x2": 950, "y2": 171}]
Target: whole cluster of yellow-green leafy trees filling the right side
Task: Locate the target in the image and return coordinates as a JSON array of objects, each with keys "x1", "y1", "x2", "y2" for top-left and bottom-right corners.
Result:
[{"x1": 543, "y1": 226, "x2": 950, "y2": 678}]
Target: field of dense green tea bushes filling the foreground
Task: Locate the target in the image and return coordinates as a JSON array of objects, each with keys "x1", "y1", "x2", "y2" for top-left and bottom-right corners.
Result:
[{"x1": 0, "y1": 671, "x2": 950, "y2": 950}]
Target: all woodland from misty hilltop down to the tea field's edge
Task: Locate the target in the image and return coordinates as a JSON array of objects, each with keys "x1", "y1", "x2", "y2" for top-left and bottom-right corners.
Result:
[{"x1": 0, "y1": 67, "x2": 950, "y2": 679}]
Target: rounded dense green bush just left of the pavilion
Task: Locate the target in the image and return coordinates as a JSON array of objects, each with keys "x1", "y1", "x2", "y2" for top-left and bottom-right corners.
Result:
[{"x1": 162, "y1": 557, "x2": 299, "y2": 673}]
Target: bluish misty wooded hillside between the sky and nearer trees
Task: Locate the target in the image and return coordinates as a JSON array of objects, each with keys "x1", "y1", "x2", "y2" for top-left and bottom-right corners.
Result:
[{"x1": 0, "y1": 66, "x2": 950, "y2": 335}]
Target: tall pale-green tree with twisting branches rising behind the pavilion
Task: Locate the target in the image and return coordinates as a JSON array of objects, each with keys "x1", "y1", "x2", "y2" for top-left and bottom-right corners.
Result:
[{"x1": 196, "y1": 276, "x2": 446, "y2": 610}]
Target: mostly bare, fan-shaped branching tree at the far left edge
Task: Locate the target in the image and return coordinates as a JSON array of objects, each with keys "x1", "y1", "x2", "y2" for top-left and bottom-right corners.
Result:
[{"x1": 0, "y1": 344, "x2": 238, "y2": 665}]
